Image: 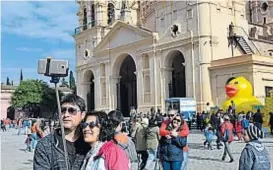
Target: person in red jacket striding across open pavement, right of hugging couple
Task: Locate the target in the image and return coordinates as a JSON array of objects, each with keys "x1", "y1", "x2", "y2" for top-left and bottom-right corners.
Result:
[{"x1": 221, "y1": 115, "x2": 234, "y2": 163}]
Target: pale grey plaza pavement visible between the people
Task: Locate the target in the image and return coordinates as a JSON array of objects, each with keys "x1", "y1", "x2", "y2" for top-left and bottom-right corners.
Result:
[{"x1": 0, "y1": 130, "x2": 273, "y2": 170}]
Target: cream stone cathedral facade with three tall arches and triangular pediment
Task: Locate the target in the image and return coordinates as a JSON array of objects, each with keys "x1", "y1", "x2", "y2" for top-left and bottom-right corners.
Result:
[{"x1": 74, "y1": 0, "x2": 273, "y2": 115}]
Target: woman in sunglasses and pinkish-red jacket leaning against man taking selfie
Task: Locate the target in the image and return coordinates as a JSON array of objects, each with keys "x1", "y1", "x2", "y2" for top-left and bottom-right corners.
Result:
[{"x1": 81, "y1": 111, "x2": 129, "y2": 170}]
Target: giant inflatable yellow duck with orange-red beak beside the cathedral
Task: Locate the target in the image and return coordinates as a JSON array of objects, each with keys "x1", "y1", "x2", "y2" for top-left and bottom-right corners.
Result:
[{"x1": 222, "y1": 77, "x2": 262, "y2": 113}]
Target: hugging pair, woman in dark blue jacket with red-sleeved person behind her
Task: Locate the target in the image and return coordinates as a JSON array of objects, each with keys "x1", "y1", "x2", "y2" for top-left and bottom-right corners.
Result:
[{"x1": 159, "y1": 113, "x2": 188, "y2": 170}]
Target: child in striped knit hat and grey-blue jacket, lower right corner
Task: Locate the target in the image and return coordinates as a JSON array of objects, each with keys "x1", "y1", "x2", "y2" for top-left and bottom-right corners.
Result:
[{"x1": 239, "y1": 125, "x2": 270, "y2": 170}]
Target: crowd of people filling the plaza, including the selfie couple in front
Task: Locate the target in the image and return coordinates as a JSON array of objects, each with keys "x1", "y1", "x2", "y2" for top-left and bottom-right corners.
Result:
[{"x1": 1, "y1": 94, "x2": 270, "y2": 170}]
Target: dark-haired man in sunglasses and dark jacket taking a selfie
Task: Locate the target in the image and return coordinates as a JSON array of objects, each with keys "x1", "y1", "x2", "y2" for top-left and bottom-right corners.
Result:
[{"x1": 33, "y1": 94, "x2": 90, "y2": 170}]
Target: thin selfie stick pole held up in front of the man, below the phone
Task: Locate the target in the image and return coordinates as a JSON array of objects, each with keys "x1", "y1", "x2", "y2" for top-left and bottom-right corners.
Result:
[{"x1": 50, "y1": 77, "x2": 69, "y2": 170}]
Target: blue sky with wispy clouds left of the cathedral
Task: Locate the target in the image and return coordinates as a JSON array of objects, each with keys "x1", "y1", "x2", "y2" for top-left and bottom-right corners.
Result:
[{"x1": 1, "y1": 1, "x2": 78, "y2": 84}]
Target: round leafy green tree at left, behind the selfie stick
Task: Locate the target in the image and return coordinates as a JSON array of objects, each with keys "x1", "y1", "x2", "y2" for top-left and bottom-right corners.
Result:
[{"x1": 11, "y1": 80, "x2": 63, "y2": 115}]
